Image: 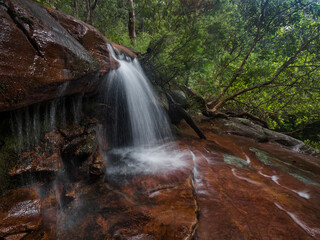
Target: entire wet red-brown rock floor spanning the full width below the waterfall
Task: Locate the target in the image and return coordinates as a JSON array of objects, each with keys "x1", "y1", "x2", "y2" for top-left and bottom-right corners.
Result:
[{"x1": 0, "y1": 117, "x2": 320, "y2": 240}]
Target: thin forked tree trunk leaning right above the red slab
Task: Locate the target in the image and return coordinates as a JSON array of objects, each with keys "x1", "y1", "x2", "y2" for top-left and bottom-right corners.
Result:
[{"x1": 208, "y1": 0, "x2": 319, "y2": 113}]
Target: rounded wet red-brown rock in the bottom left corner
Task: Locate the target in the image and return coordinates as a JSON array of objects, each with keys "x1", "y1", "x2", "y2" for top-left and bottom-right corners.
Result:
[{"x1": 0, "y1": 188, "x2": 42, "y2": 239}]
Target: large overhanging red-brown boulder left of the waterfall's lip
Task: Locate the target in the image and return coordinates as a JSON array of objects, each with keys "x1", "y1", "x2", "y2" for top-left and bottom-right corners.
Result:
[{"x1": 0, "y1": 0, "x2": 134, "y2": 111}]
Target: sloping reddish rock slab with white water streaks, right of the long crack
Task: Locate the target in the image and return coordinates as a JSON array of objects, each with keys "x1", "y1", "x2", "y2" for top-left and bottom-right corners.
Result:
[{"x1": 182, "y1": 120, "x2": 320, "y2": 240}]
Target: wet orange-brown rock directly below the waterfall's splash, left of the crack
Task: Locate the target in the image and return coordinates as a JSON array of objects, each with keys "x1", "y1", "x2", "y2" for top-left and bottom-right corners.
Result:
[{"x1": 51, "y1": 169, "x2": 197, "y2": 239}]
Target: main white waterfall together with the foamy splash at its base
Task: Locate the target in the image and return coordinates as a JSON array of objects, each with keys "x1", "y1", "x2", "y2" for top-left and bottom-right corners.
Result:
[{"x1": 102, "y1": 45, "x2": 185, "y2": 177}]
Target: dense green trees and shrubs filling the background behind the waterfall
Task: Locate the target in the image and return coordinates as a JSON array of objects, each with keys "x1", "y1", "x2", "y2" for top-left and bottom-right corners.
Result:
[{"x1": 35, "y1": 0, "x2": 320, "y2": 148}]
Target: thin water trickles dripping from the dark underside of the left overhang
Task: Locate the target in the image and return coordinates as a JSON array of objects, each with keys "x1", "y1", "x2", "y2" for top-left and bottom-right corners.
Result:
[{"x1": 10, "y1": 82, "x2": 82, "y2": 154}]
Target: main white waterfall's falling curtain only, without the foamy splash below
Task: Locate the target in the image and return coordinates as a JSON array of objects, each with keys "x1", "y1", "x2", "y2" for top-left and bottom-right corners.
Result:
[{"x1": 103, "y1": 45, "x2": 172, "y2": 147}]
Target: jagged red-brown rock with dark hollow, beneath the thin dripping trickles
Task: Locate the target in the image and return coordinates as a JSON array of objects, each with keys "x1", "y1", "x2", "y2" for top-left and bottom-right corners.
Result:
[{"x1": 9, "y1": 123, "x2": 97, "y2": 178}]
